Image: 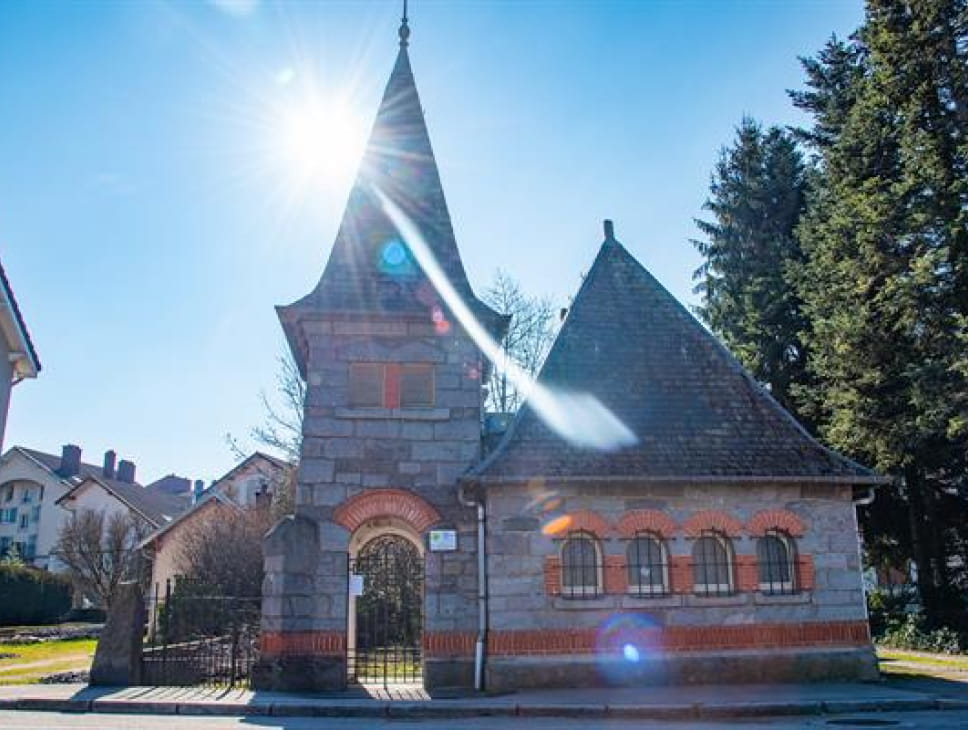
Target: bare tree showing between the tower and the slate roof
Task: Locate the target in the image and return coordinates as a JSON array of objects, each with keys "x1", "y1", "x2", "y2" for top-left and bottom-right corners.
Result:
[{"x1": 481, "y1": 269, "x2": 556, "y2": 413}]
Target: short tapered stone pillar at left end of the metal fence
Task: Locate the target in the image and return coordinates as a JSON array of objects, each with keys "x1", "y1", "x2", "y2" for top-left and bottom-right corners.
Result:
[{"x1": 90, "y1": 583, "x2": 146, "y2": 687}]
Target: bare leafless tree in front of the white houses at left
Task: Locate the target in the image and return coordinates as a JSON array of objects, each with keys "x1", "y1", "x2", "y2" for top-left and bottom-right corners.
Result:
[{"x1": 53, "y1": 509, "x2": 151, "y2": 609}]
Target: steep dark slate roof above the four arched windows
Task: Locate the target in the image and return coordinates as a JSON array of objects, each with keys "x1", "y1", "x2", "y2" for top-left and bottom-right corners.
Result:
[{"x1": 471, "y1": 224, "x2": 884, "y2": 484}]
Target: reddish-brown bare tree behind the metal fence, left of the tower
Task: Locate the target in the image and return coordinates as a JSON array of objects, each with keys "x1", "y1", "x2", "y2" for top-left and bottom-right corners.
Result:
[{"x1": 176, "y1": 502, "x2": 271, "y2": 597}]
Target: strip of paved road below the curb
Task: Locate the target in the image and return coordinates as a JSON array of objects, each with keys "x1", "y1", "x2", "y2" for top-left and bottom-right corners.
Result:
[{"x1": 0, "y1": 711, "x2": 968, "y2": 730}]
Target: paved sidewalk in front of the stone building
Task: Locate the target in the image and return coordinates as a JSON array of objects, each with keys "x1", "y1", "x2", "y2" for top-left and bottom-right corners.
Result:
[{"x1": 0, "y1": 679, "x2": 968, "y2": 720}]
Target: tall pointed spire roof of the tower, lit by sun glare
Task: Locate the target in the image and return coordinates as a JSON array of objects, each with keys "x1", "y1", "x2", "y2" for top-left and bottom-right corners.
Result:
[{"x1": 277, "y1": 25, "x2": 507, "y2": 376}]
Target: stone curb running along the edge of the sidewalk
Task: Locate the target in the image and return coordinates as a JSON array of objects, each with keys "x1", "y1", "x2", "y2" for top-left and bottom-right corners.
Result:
[{"x1": 0, "y1": 697, "x2": 968, "y2": 720}]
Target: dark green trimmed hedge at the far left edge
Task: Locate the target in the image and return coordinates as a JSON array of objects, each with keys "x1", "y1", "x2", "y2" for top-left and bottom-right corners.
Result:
[{"x1": 0, "y1": 565, "x2": 71, "y2": 626}]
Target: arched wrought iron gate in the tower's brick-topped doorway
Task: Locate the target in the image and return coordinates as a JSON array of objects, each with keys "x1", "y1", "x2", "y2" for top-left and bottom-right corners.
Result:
[{"x1": 347, "y1": 535, "x2": 423, "y2": 684}]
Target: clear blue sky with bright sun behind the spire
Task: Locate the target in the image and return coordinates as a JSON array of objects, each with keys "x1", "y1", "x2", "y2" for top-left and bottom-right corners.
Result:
[{"x1": 0, "y1": 0, "x2": 863, "y2": 481}]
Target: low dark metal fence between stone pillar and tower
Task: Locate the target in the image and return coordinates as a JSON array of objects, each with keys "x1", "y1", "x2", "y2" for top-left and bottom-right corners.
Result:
[{"x1": 142, "y1": 582, "x2": 262, "y2": 687}]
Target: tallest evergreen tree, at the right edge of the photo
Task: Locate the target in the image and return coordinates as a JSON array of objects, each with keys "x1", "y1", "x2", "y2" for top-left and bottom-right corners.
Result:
[{"x1": 794, "y1": 0, "x2": 968, "y2": 623}]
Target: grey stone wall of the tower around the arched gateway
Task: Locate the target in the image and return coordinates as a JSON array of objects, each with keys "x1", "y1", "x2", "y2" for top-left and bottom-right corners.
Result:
[{"x1": 263, "y1": 320, "x2": 482, "y2": 686}]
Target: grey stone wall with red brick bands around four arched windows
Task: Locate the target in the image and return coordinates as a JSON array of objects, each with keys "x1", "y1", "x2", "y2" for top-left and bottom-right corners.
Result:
[{"x1": 487, "y1": 481, "x2": 873, "y2": 689}]
